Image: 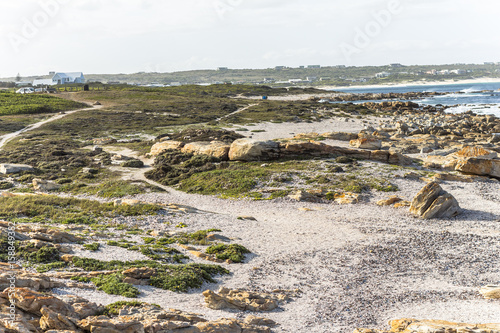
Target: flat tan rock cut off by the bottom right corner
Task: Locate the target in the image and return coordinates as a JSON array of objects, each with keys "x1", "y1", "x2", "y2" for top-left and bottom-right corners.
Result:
[{"x1": 354, "y1": 319, "x2": 500, "y2": 333}]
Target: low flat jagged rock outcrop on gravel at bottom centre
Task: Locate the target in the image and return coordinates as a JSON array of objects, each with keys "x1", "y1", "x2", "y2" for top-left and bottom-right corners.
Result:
[{"x1": 203, "y1": 287, "x2": 289, "y2": 311}]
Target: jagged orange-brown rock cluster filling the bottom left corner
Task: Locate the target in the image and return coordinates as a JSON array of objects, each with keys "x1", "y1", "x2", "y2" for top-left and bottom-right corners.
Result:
[{"x1": 0, "y1": 288, "x2": 275, "y2": 333}]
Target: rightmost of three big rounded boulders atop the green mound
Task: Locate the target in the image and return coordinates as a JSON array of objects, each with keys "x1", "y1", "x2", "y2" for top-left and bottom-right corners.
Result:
[{"x1": 229, "y1": 139, "x2": 280, "y2": 161}]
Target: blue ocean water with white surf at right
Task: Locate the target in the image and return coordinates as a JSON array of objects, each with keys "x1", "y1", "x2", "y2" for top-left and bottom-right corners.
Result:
[{"x1": 335, "y1": 83, "x2": 500, "y2": 117}]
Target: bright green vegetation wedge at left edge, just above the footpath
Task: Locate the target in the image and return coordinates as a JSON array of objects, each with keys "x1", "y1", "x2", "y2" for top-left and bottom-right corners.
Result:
[{"x1": 0, "y1": 91, "x2": 87, "y2": 116}]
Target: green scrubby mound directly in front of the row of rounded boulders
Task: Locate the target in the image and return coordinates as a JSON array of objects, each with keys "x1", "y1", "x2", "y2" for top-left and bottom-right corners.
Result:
[{"x1": 148, "y1": 155, "x2": 398, "y2": 200}]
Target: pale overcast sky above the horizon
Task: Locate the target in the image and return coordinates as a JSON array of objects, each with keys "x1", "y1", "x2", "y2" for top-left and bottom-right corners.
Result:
[{"x1": 0, "y1": 0, "x2": 500, "y2": 77}]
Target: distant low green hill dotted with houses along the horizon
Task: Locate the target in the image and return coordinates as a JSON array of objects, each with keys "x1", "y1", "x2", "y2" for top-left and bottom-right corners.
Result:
[{"x1": 0, "y1": 64, "x2": 500, "y2": 86}]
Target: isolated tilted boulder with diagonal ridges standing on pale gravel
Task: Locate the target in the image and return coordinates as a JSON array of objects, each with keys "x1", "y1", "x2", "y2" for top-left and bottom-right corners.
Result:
[{"x1": 410, "y1": 182, "x2": 460, "y2": 219}]
